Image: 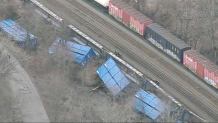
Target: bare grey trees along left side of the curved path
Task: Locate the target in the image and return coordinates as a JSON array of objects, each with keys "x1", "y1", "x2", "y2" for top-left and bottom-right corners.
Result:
[{"x1": 0, "y1": 36, "x2": 30, "y2": 122}]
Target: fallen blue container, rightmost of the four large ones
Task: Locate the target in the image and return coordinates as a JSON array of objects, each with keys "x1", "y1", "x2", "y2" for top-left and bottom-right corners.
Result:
[{"x1": 133, "y1": 89, "x2": 165, "y2": 120}]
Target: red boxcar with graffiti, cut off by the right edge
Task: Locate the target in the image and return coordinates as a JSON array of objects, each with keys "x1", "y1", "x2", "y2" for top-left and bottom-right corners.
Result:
[{"x1": 183, "y1": 50, "x2": 218, "y2": 88}]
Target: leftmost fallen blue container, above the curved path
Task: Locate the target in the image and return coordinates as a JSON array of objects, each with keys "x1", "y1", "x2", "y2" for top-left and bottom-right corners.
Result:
[{"x1": 0, "y1": 19, "x2": 37, "y2": 49}]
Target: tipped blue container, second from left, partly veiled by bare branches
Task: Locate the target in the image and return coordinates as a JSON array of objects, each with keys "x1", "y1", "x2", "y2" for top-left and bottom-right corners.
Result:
[{"x1": 49, "y1": 37, "x2": 95, "y2": 66}]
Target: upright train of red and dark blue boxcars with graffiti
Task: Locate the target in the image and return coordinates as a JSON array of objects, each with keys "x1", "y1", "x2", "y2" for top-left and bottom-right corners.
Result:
[{"x1": 88, "y1": 0, "x2": 218, "y2": 88}]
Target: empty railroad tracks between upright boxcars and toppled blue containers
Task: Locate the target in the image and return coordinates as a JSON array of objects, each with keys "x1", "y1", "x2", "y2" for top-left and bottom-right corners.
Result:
[{"x1": 40, "y1": 0, "x2": 218, "y2": 120}]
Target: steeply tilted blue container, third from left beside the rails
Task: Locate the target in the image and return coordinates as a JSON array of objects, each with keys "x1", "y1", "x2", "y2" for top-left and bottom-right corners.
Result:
[{"x1": 97, "y1": 58, "x2": 129, "y2": 96}]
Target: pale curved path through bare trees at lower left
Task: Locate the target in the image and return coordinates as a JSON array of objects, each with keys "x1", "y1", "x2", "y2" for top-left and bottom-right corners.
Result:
[{"x1": 0, "y1": 45, "x2": 49, "y2": 122}]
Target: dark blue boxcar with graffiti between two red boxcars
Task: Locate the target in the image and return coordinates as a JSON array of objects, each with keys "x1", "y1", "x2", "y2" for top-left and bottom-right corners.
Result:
[{"x1": 144, "y1": 23, "x2": 191, "y2": 63}]
